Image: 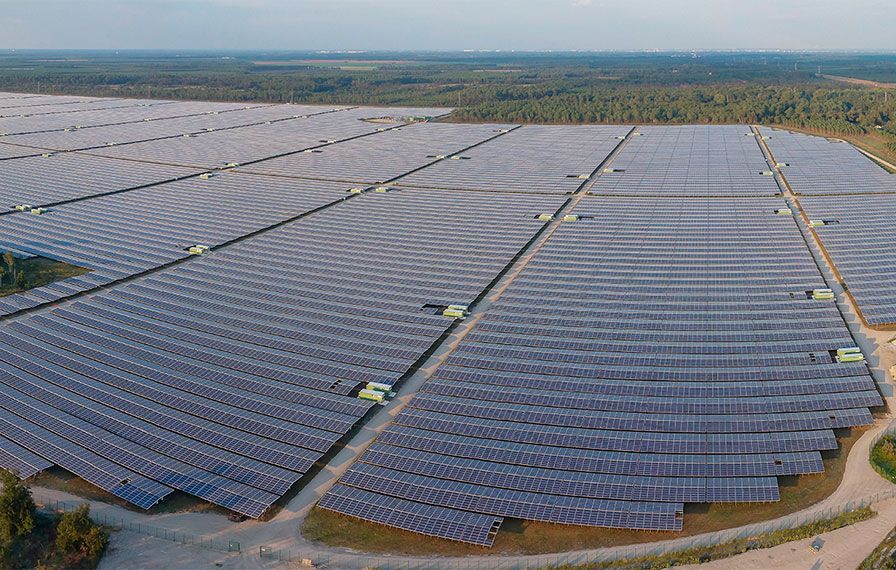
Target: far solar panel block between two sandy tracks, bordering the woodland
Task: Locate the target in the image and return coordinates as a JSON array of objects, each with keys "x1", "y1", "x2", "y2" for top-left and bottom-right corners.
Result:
[{"x1": 591, "y1": 125, "x2": 780, "y2": 196}]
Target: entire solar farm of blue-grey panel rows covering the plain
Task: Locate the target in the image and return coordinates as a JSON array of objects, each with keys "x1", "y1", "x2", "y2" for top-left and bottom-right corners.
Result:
[{"x1": 0, "y1": 93, "x2": 896, "y2": 547}]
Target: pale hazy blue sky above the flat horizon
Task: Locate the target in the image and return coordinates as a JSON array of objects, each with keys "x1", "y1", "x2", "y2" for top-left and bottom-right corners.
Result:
[{"x1": 0, "y1": 0, "x2": 896, "y2": 50}]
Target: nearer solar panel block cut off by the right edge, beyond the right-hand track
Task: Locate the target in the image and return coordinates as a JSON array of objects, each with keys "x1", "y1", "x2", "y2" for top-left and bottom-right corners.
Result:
[{"x1": 800, "y1": 194, "x2": 896, "y2": 326}]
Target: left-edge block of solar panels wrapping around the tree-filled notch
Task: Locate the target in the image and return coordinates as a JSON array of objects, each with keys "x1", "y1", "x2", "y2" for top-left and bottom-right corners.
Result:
[{"x1": 0, "y1": 173, "x2": 348, "y2": 314}]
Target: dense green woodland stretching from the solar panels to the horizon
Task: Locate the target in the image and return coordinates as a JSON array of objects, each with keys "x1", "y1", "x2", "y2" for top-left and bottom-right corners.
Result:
[{"x1": 0, "y1": 51, "x2": 896, "y2": 151}]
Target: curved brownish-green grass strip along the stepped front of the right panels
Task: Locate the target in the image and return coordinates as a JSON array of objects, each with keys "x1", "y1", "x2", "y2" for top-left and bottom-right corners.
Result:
[{"x1": 301, "y1": 428, "x2": 865, "y2": 556}]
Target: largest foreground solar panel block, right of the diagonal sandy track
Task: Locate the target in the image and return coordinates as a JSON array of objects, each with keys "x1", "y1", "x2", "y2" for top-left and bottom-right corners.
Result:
[{"x1": 320, "y1": 197, "x2": 882, "y2": 545}]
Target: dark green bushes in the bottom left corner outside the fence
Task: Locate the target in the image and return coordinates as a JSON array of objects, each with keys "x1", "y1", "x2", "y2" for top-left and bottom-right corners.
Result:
[{"x1": 0, "y1": 470, "x2": 109, "y2": 570}]
